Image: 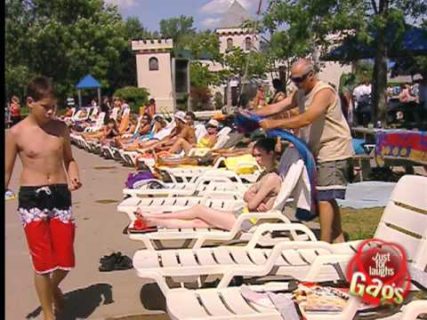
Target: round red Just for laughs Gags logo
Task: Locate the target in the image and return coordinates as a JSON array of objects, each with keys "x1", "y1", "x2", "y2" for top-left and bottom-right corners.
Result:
[{"x1": 347, "y1": 239, "x2": 411, "y2": 305}]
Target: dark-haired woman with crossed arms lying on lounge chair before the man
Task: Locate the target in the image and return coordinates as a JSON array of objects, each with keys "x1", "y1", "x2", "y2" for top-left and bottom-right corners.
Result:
[{"x1": 137, "y1": 138, "x2": 281, "y2": 230}]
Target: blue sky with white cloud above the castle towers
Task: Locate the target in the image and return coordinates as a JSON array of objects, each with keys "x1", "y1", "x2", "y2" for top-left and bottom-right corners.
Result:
[{"x1": 105, "y1": 0, "x2": 268, "y2": 31}]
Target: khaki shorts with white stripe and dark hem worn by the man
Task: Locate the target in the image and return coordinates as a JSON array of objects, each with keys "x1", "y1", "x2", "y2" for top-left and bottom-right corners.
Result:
[{"x1": 316, "y1": 158, "x2": 353, "y2": 201}]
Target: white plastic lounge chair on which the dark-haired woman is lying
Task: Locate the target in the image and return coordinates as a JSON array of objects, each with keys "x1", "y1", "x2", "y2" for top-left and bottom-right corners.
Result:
[{"x1": 122, "y1": 160, "x2": 307, "y2": 249}]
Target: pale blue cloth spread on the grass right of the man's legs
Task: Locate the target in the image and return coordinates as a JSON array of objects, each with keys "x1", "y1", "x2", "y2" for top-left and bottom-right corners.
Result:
[{"x1": 337, "y1": 181, "x2": 396, "y2": 209}]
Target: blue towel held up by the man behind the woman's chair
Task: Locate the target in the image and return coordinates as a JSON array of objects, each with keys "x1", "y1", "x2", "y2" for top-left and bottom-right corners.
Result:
[{"x1": 235, "y1": 114, "x2": 318, "y2": 220}]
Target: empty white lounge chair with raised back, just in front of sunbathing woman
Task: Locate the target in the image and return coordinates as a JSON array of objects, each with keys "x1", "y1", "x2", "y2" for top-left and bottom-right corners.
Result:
[{"x1": 133, "y1": 176, "x2": 427, "y2": 293}]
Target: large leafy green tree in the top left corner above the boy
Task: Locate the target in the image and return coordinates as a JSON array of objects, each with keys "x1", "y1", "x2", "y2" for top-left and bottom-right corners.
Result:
[{"x1": 5, "y1": 0, "x2": 130, "y2": 102}]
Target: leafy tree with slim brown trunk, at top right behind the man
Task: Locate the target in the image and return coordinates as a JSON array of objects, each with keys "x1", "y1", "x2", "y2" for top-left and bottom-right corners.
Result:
[{"x1": 264, "y1": 0, "x2": 427, "y2": 125}]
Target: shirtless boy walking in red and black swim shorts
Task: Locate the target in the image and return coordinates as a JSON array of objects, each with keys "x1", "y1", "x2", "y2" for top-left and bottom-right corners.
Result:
[{"x1": 5, "y1": 77, "x2": 81, "y2": 320}]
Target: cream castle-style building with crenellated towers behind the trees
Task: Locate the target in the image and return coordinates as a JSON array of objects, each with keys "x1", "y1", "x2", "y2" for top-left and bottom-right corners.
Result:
[{"x1": 132, "y1": 0, "x2": 351, "y2": 112}]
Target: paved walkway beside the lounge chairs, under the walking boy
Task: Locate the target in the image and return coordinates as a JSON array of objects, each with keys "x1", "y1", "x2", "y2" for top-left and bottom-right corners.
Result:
[{"x1": 5, "y1": 147, "x2": 167, "y2": 320}]
